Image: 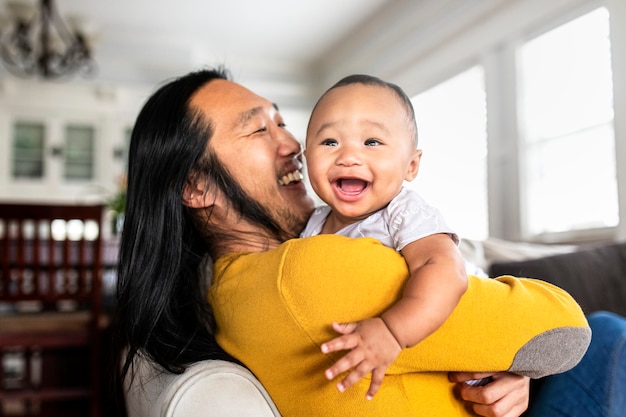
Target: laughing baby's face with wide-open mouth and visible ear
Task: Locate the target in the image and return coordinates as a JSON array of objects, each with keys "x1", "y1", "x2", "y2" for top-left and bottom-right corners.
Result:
[{"x1": 305, "y1": 84, "x2": 421, "y2": 220}]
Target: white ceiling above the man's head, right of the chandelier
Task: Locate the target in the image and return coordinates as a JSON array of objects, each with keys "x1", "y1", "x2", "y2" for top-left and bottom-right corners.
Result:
[{"x1": 0, "y1": 0, "x2": 394, "y2": 88}]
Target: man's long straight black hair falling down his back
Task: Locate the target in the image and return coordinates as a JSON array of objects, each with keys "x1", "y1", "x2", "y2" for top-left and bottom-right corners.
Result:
[{"x1": 112, "y1": 68, "x2": 291, "y2": 408}]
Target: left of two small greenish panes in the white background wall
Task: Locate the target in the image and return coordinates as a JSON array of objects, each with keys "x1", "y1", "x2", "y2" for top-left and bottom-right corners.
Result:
[{"x1": 12, "y1": 122, "x2": 45, "y2": 179}]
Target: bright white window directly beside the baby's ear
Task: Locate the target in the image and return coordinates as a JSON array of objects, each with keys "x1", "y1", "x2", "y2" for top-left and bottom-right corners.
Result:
[{"x1": 407, "y1": 66, "x2": 488, "y2": 239}]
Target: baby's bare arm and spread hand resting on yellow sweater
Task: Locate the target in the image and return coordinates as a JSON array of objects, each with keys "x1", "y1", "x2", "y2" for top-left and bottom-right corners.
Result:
[{"x1": 322, "y1": 234, "x2": 467, "y2": 398}]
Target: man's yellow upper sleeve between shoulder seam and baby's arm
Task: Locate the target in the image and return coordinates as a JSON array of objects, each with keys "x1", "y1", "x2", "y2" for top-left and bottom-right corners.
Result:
[{"x1": 276, "y1": 234, "x2": 408, "y2": 334}]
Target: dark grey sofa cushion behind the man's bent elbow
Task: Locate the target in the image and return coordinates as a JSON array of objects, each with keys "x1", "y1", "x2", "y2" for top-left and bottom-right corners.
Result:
[{"x1": 489, "y1": 243, "x2": 626, "y2": 315}]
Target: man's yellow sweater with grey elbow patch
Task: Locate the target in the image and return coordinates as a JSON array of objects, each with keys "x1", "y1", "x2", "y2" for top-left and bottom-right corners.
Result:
[{"x1": 209, "y1": 235, "x2": 590, "y2": 417}]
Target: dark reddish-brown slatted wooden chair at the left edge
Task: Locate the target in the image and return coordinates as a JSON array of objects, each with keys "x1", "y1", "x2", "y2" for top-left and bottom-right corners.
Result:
[{"x1": 0, "y1": 204, "x2": 104, "y2": 417}]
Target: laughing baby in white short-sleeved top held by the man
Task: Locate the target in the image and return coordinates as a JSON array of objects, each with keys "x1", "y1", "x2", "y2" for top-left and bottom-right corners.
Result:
[{"x1": 301, "y1": 75, "x2": 467, "y2": 399}]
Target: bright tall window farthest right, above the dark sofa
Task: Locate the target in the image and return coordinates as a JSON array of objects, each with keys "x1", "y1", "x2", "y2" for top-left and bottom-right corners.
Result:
[{"x1": 519, "y1": 8, "x2": 619, "y2": 236}]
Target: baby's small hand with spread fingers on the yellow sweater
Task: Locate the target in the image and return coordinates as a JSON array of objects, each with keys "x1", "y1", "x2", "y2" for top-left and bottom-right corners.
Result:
[{"x1": 322, "y1": 318, "x2": 402, "y2": 400}]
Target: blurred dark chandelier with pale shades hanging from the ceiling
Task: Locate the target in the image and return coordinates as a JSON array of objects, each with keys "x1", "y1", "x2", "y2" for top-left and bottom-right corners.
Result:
[{"x1": 0, "y1": 0, "x2": 95, "y2": 79}]
